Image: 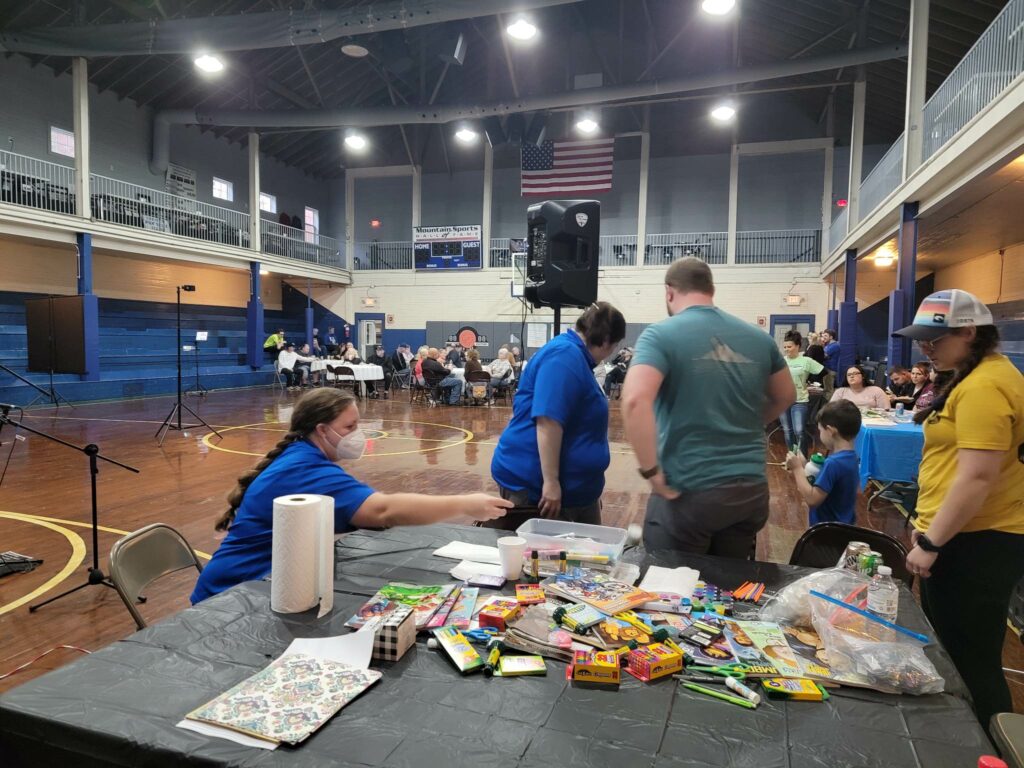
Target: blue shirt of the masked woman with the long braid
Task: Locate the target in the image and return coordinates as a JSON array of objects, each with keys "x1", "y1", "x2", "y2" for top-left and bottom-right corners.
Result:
[{"x1": 191, "y1": 440, "x2": 374, "y2": 603}]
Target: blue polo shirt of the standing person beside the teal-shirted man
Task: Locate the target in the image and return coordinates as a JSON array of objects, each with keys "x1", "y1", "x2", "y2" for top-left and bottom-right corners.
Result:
[{"x1": 490, "y1": 331, "x2": 611, "y2": 507}]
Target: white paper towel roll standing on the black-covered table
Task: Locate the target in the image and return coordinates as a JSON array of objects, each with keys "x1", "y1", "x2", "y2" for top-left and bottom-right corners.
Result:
[{"x1": 270, "y1": 494, "x2": 334, "y2": 616}]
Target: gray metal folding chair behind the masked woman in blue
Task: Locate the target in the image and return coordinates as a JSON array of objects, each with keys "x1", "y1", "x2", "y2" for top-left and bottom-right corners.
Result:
[{"x1": 111, "y1": 522, "x2": 203, "y2": 630}]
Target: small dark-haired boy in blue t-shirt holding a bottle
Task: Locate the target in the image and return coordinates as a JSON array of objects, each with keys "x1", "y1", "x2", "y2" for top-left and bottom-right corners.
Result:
[{"x1": 785, "y1": 400, "x2": 860, "y2": 525}]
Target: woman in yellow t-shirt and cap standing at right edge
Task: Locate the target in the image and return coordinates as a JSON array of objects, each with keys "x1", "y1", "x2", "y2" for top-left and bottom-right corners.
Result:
[{"x1": 896, "y1": 290, "x2": 1024, "y2": 729}]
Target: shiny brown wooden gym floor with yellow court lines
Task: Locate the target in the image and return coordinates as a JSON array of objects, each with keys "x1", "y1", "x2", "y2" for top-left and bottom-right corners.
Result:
[{"x1": 0, "y1": 388, "x2": 1024, "y2": 712}]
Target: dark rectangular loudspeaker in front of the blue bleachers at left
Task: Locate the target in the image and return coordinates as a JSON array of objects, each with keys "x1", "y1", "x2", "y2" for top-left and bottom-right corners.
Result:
[{"x1": 25, "y1": 296, "x2": 88, "y2": 375}]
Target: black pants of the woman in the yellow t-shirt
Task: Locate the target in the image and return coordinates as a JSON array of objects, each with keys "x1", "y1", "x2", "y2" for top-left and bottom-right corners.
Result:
[{"x1": 921, "y1": 530, "x2": 1024, "y2": 730}]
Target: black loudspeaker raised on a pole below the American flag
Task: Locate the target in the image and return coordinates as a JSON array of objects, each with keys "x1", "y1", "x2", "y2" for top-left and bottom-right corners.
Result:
[{"x1": 524, "y1": 200, "x2": 601, "y2": 307}]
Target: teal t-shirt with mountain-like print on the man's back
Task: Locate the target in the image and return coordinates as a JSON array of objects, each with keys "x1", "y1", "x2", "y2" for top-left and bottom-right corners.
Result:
[{"x1": 633, "y1": 305, "x2": 785, "y2": 490}]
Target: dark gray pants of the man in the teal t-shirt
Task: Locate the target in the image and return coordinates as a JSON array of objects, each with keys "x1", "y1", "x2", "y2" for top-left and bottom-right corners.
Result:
[{"x1": 643, "y1": 480, "x2": 769, "y2": 559}]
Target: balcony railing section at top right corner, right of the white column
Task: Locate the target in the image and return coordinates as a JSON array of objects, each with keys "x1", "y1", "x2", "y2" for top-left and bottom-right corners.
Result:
[{"x1": 925, "y1": 0, "x2": 1024, "y2": 160}]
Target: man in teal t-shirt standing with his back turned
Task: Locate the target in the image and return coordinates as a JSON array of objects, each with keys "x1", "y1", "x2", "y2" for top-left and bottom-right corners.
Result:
[{"x1": 623, "y1": 256, "x2": 796, "y2": 557}]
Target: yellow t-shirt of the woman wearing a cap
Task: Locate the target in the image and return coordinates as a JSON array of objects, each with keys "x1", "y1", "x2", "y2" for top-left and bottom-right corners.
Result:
[{"x1": 913, "y1": 354, "x2": 1024, "y2": 534}]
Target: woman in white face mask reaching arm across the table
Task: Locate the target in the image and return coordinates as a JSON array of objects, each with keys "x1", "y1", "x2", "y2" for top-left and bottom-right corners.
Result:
[{"x1": 191, "y1": 389, "x2": 512, "y2": 603}]
